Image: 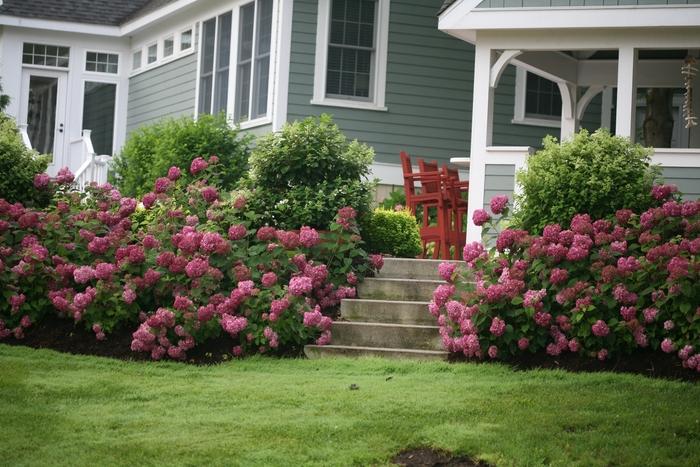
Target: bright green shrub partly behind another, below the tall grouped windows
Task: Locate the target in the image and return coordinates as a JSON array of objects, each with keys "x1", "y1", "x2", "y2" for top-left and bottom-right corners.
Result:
[{"x1": 112, "y1": 114, "x2": 250, "y2": 196}]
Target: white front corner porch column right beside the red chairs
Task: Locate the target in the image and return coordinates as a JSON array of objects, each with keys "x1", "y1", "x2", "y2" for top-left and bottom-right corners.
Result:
[{"x1": 467, "y1": 40, "x2": 494, "y2": 242}]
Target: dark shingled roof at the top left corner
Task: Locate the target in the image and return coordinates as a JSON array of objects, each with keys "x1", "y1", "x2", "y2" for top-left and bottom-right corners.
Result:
[{"x1": 0, "y1": 0, "x2": 172, "y2": 26}]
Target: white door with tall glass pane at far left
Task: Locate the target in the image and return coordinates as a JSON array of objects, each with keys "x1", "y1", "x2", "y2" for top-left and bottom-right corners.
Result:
[{"x1": 19, "y1": 68, "x2": 68, "y2": 175}]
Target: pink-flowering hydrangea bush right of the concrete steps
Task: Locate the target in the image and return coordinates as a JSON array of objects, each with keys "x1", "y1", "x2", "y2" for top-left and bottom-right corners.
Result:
[{"x1": 429, "y1": 185, "x2": 700, "y2": 372}]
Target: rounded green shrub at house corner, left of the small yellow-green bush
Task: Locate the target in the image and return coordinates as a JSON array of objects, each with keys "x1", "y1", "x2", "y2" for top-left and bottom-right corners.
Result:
[{"x1": 244, "y1": 115, "x2": 374, "y2": 229}]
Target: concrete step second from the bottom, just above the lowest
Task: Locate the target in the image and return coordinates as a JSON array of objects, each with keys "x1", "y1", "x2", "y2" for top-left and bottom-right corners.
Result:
[{"x1": 332, "y1": 321, "x2": 443, "y2": 350}]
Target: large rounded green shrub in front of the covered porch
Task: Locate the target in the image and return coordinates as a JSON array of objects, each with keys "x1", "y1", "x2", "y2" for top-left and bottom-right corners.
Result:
[{"x1": 515, "y1": 129, "x2": 660, "y2": 233}]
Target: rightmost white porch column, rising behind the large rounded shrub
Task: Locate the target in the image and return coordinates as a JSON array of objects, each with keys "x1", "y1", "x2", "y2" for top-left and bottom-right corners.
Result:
[{"x1": 615, "y1": 46, "x2": 638, "y2": 141}]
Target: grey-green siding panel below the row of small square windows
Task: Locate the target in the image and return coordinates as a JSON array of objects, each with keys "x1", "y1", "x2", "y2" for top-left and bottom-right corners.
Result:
[{"x1": 126, "y1": 54, "x2": 197, "y2": 133}]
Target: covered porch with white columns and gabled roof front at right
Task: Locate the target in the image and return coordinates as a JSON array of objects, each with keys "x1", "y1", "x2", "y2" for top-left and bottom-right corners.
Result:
[{"x1": 439, "y1": 0, "x2": 700, "y2": 241}]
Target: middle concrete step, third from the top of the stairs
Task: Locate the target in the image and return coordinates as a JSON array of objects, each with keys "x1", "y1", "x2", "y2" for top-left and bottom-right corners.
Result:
[{"x1": 340, "y1": 299, "x2": 436, "y2": 325}]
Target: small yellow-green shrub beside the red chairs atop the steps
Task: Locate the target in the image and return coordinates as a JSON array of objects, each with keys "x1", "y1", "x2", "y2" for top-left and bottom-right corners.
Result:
[{"x1": 362, "y1": 208, "x2": 421, "y2": 258}]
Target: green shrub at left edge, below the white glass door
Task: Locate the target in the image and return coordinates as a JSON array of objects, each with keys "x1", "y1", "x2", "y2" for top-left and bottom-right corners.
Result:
[{"x1": 0, "y1": 114, "x2": 50, "y2": 206}]
